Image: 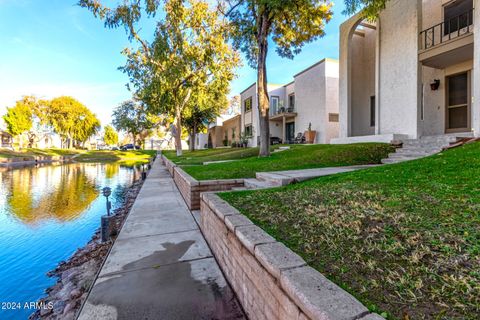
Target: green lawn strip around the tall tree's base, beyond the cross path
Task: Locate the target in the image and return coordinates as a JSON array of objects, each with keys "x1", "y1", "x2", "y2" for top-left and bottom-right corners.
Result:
[{"x1": 166, "y1": 143, "x2": 393, "y2": 180}]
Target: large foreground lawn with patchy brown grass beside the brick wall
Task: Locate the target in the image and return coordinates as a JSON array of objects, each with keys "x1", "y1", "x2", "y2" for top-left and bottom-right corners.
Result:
[{"x1": 221, "y1": 143, "x2": 480, "y2": 319}]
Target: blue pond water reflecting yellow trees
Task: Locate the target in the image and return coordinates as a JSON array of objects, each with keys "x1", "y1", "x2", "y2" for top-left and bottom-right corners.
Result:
[{"x1": 0, "y1": 163, "x2": 140, "y2": 319}]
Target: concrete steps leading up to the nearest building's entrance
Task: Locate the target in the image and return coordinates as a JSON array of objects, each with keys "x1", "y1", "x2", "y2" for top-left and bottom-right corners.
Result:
[{"x1": 382, "y1": 134, "x2": 473, "y2": 164}]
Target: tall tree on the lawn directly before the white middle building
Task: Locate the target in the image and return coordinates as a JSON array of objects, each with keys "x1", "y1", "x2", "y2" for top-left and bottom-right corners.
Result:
[{"x1": 224, "y1": 0, "x2": 332, "y2": 156}]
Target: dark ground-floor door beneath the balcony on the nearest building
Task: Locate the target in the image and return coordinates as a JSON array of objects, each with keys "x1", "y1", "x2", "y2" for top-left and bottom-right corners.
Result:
[{"x1": 446, "y1": 72, "x2": 471, "y2": 133}]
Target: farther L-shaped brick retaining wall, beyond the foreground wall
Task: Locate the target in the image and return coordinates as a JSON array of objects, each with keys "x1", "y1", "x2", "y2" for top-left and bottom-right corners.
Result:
[{"x1": 161, "y1": 155, "x2": 244, "y2": 210}]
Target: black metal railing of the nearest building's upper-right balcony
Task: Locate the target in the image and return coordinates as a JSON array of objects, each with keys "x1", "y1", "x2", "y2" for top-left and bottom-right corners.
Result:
[{"x1": 420, "y1": 9, "x2": 473, "y2": 50}]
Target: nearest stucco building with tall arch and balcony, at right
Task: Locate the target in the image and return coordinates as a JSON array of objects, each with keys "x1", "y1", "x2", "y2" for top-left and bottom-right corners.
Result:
[{"x1": 332, "y1": 0, "x2": 480, "y2": 143}]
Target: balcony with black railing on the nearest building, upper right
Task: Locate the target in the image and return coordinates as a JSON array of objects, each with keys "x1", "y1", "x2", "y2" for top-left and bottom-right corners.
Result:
[{"x1": 419, "y1": 9, "x2": 473, "y2": 69}]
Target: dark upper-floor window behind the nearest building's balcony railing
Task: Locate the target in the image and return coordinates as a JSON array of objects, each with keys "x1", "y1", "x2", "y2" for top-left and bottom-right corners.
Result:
[{"x1": 443, "y1": 0, "x2": 473, "y2": 35}]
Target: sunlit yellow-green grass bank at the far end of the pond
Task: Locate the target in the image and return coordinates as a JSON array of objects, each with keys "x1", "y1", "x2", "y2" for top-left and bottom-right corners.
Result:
[{"x1": 75, "y1": 150, "x2": 157, "y2": 163}]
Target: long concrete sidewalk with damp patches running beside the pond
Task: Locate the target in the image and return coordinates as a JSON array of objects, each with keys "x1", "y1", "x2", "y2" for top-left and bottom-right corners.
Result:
[{"x1": 78, "y1": 160, "x2": 245, "y2": 320}]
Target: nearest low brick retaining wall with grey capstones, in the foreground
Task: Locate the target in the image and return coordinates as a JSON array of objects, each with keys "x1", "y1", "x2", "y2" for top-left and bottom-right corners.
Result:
[{"x1": 200, "y1": 193, "x2": 383, "y2": 320}]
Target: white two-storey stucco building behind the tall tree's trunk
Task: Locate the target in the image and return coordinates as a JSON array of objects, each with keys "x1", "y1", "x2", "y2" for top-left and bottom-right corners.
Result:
[{"x1": 240, "y1": 59, "x2": 339, "y2": 146}]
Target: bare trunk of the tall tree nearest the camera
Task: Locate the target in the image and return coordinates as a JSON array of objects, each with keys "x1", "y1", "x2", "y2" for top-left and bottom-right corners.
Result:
[{"x1": 254, "y1": 13, "x2": 270, "y2": 157}]
